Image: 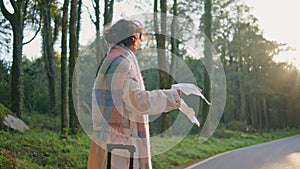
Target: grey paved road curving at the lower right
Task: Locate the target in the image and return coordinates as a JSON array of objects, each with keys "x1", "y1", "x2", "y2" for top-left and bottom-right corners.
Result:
[{"x1": 186, "y1": 135, "x2": 300, "y2": 169}]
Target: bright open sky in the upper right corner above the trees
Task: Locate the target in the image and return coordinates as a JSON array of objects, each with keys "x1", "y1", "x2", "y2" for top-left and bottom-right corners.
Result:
[{"x1": 244, "y1": 0, "x2": 300, "y2": 70}]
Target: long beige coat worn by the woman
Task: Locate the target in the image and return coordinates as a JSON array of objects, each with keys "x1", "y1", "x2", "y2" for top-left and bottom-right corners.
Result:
[{"x1": 88, "y1": 46, "x2": 180, "y2": 169}]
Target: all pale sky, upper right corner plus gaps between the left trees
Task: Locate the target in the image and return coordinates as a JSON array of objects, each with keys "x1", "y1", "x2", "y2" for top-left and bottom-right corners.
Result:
[{"x1": 19, "y1": 0, "x2": 300, "y2": 70}]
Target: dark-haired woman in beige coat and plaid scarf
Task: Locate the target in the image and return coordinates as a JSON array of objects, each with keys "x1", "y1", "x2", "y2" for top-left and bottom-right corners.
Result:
[{"x1": 88, "y1": 19, "x2": 181, "y2": 169}]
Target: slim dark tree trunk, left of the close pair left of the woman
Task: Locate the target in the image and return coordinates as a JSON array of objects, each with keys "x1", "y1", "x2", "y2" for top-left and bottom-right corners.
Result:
[{"x1": 61, "y1": 0, "x2": 70, "y2": 134}]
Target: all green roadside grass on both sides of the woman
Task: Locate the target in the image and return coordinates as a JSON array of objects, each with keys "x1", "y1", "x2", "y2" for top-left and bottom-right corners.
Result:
[{"x1": 0, "y1": 129, "x2": 300, "y2": 169}]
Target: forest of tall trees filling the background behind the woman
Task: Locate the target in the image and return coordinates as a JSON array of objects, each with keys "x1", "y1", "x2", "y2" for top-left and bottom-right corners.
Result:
[{"x1": 0, "y1": 0, "x2": 300, "y2": 168}]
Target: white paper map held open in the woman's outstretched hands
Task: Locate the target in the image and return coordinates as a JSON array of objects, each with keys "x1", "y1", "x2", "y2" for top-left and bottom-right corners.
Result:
[{"x1": 172, "y1": 83, "x2": 211, "y2": 127}]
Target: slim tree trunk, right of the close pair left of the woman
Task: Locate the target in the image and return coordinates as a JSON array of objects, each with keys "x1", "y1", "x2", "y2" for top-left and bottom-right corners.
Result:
[{"x1": 69, "y1": 0, "x2": 79, "y2": 133}]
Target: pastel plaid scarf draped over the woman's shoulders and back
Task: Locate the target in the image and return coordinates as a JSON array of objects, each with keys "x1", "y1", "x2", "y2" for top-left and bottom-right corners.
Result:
[{"x1": 93, "y1": 46, "x2": 151, "y2": 168}]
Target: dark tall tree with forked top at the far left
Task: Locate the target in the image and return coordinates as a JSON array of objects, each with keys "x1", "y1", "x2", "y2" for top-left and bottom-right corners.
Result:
[{"x1": 0, "y1": 0, "x2": 39, "y2": 118}]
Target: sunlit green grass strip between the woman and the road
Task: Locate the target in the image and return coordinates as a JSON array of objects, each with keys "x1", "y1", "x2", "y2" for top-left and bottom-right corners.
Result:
[{"x1": 152, "y1": 129, "x2": 300, "y2": 169}]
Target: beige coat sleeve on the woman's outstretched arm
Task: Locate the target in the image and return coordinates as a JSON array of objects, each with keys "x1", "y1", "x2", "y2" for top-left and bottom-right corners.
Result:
[{"x1": 122, "y1": 64, "x2": 181, "y2": 115}]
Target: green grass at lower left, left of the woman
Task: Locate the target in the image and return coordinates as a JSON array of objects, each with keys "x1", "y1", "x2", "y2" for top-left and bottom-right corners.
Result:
[{"x1": 0, "y1": 131, "x2": 89, "y2": 169}]
